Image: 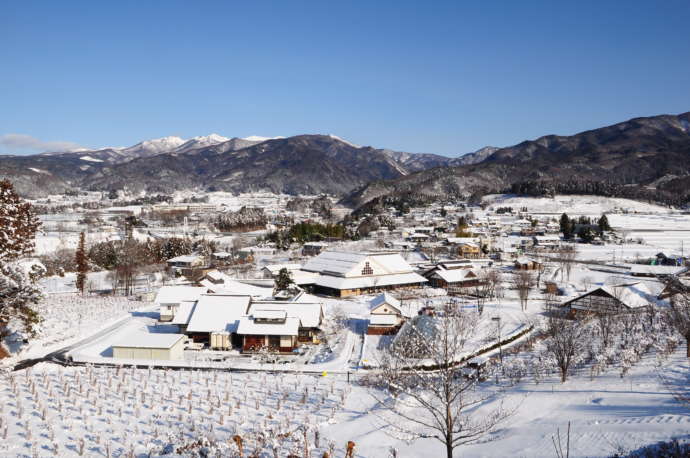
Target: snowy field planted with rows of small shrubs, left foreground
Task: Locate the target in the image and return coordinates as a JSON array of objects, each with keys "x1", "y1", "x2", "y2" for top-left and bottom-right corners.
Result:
[{"x1": 0, "y1": 364, "x2": 350, "y2": 457}]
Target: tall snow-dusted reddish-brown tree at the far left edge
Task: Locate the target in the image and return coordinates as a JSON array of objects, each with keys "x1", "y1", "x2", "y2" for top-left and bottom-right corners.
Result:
[{"x1": 0, "y1": 180, "x2": 42, "y2": 336}]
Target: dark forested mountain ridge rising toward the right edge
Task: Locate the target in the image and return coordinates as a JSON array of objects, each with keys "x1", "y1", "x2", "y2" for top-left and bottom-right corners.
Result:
[{"x1": 343, "y1": 113, "x2": 690, "y2": 210}]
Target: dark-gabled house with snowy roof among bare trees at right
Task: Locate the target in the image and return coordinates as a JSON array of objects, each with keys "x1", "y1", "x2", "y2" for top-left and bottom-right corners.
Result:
[{"x1": 562, "y1": 282, "x2": 656, "y2": 315}]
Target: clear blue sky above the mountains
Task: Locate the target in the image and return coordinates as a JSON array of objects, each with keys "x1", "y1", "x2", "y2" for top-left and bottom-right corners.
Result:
[{"x1": 0, "y1": 0, "x2": 690, "y2": 156}]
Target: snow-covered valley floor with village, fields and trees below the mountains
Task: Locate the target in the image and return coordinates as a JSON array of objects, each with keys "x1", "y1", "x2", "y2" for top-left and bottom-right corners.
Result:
[{"x1": 0, "y1": 184, "x2": 690, "y2": 457}]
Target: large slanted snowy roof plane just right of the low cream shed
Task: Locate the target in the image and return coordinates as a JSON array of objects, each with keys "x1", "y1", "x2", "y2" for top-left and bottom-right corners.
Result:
[{"x1": 187, "y1": 294, "x2": 249, "y2": 332}]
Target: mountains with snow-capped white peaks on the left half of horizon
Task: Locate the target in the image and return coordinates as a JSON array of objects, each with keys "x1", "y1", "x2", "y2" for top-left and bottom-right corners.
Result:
[{"x1": 0, "y1": 134, "x2": 482, "y2": 196}]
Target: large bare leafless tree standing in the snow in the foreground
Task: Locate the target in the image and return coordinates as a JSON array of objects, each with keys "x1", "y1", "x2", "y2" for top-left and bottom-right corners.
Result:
[{"x1": 371, "y1": 302, "x2": 514, "y2": 458}]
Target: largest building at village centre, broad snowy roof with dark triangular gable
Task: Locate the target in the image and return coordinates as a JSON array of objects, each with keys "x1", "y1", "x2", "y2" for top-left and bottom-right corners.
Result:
[{"x1": 302, "y1": 251, "x2": 427, "y2": 297}]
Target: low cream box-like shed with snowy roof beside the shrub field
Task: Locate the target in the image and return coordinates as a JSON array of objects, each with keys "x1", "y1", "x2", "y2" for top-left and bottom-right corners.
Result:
[{"x1": 113, "y1": 333, "x2": 185, "y2": 361}]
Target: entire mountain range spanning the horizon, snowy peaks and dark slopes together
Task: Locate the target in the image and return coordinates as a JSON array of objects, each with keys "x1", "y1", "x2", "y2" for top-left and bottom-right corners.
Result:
[{"x1": 0, "y1": 113, "x2": 690, "y2": 207}]
